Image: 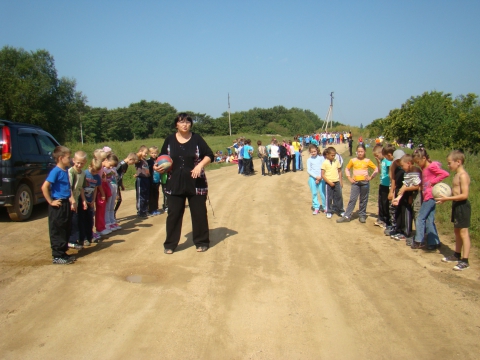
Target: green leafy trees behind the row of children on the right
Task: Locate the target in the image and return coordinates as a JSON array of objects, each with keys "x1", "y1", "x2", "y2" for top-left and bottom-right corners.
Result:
[{"x1": 365, "y1": 91, "x2": 480, "y2": 153}]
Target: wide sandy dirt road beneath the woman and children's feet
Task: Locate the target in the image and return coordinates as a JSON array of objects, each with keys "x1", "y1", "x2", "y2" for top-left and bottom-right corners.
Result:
[{"x1": 0, "y1": 145, "x2": 480, "y2": 359}]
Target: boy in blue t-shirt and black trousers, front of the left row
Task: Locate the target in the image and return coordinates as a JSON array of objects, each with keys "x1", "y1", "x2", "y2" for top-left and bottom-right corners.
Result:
[{"x1": 42, "y1": 146, "x2": 75, "y2": 265}]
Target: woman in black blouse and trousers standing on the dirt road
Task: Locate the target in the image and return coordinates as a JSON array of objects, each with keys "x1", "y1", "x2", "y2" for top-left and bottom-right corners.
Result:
[{"x1": 160, "y1": 113, "x2": 213, "y2": 254}]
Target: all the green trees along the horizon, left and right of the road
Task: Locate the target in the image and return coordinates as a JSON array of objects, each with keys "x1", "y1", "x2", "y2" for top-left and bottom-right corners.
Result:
[{"x1": 0, "y1": 46, "x2": 480, "y2": 153}]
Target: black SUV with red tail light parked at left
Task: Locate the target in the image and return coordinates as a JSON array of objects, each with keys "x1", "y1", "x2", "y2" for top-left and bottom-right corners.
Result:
[{"x1": 0, "y1": 120, "x2": 59, "y2": 221}]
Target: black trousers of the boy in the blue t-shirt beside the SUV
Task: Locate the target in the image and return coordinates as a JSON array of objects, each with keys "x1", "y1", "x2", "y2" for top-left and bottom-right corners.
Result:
[{"x1": 48, "y1": 199, "x2": 71, "y2": 258}]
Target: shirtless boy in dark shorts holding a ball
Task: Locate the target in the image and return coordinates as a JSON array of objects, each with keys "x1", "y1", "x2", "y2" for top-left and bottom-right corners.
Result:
[{"x1": 435, "y1": 150, "x2": 471, "y2": 271}]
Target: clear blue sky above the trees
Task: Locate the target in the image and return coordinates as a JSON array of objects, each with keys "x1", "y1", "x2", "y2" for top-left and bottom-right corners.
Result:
[{"x1": 0, "y1": 0, "x2": 480, "y2": 125}]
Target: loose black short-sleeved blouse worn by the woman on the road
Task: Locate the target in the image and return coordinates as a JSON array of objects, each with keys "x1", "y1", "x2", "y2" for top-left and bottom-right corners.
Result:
[{"x1": 160, "y1": 133, "x2": 213, "y2": 195}]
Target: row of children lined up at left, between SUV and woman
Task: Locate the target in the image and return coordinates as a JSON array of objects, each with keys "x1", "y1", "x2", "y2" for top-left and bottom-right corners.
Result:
[{"x1": 42, "y1": 146, "x2": 168, "y2": 264}]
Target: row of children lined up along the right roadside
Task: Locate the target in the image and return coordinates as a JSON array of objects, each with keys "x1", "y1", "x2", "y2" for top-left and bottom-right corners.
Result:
[{"x1": 307, "y1": 144, "x2": 471, "y2": 270}]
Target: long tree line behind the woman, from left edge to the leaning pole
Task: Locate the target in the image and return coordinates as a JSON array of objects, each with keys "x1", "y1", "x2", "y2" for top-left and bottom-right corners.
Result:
[{"x1": 0, "y1": 46, "x2": 332, "y2": 143}]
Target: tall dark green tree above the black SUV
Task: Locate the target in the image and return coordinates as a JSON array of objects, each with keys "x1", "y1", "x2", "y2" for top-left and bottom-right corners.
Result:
[{"x1": 0, "y1": 46, "x2": 86, "y2": 141}]
